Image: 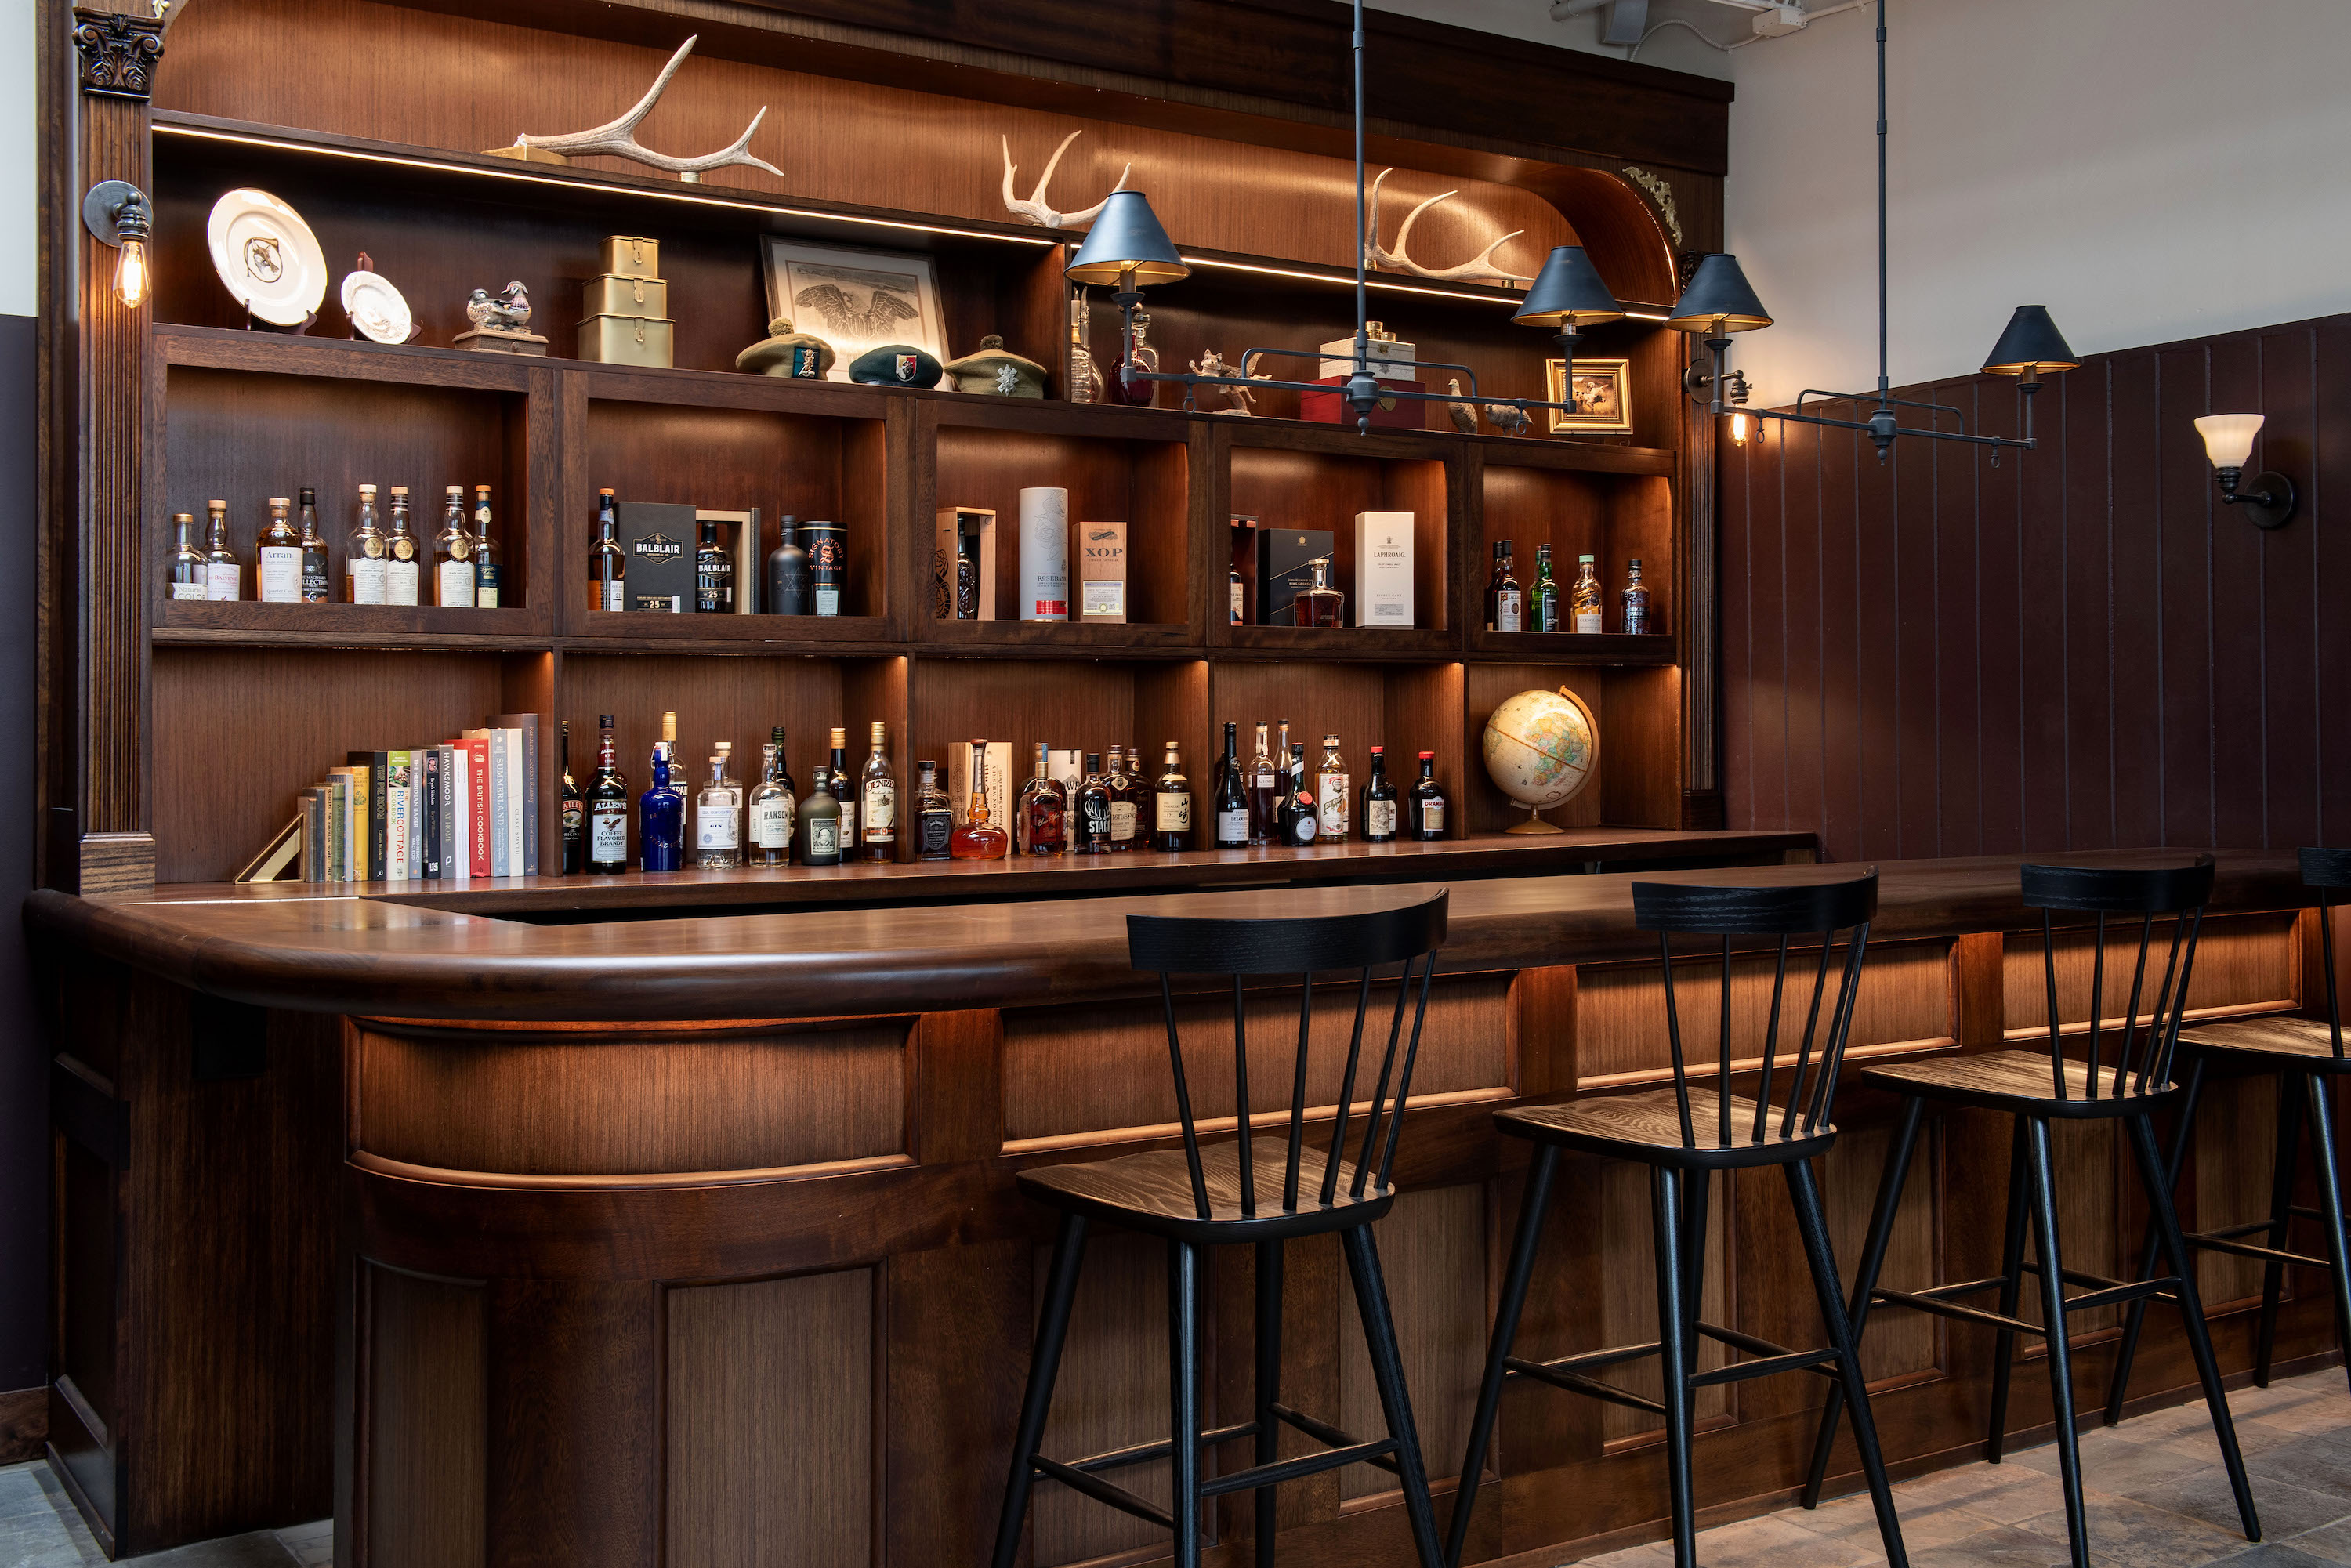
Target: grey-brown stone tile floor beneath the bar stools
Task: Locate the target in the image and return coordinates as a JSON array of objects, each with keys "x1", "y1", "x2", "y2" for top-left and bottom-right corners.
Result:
[{"x1": 0, "y1": 1371, "x2": 2351, "y2": 1568}]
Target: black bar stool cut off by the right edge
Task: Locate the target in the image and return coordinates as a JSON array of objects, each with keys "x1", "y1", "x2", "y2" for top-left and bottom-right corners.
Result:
[{"x1": 2106, "y1": 849, "x2": 2351, "y2": 1425}]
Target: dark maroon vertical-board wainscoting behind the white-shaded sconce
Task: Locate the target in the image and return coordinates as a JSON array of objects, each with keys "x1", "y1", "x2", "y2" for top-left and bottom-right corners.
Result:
[{"x1": 1721, "y1": 315, "x2": 2351, "y2": 860}]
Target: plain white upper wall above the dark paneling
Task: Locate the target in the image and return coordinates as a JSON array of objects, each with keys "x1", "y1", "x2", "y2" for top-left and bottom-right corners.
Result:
[{"x1": 1728, "y1": 0, "x2": 2351, "y2": 407}]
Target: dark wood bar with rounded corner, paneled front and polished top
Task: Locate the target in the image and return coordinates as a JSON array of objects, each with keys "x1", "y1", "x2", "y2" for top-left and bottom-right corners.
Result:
[{"x1": 28, "y1": 851, "x2": 2335, "y2": 1568}]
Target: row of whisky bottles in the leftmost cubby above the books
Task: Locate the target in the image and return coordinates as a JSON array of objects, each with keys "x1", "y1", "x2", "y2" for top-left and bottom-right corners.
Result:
[{"x1": 167, "y1": 484, "x2": 501, "y2": 609}]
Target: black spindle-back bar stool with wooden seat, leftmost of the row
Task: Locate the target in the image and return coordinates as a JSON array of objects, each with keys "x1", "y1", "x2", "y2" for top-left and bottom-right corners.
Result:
[{"x1": 994, "y1": 891, "x2": 1448, "y2": 1568}]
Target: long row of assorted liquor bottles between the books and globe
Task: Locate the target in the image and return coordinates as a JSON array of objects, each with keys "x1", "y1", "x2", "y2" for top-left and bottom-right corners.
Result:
[{"x1": 560, "y1": 712, "x2": 1446, "y2": 875}]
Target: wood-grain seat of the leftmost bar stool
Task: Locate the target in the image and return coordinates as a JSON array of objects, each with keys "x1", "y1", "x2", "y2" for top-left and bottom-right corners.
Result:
[{"x1": 1020, "y1": 1138, "x2": 1396, "y2": 1244}]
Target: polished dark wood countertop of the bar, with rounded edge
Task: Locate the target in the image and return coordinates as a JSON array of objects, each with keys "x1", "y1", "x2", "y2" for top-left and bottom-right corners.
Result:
[{"x1": 26, "y1": 851, "x2": 2311, "y2": 1020}]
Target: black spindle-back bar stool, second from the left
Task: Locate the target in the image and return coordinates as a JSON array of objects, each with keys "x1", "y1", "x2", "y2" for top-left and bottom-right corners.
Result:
[{"x1": 1446, "y1": 867, "x2": 1909, "y2": 1568}]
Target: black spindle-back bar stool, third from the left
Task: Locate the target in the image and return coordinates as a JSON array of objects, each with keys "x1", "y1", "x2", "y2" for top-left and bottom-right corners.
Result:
[{"x1": 1803, "y1": 856, "x2": 2262, "y2": 1568}]
